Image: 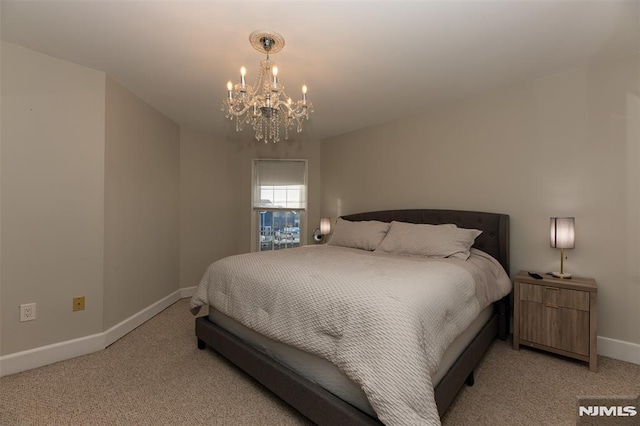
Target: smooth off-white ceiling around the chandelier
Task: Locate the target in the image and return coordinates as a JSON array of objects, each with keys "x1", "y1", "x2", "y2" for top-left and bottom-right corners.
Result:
[{"x1": 0, "y1": 0, "x2": 640, "y2": 139}]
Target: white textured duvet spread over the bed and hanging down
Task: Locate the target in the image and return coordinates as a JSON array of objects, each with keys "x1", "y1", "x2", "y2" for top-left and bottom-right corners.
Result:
[{"x1": 191, "y1": 245, "x2": 511, "y2": 426}]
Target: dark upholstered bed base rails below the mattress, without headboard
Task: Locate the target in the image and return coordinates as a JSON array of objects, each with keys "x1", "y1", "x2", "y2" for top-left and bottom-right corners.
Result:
[{"x1": 196, "y1": 297, "x2": 509, "y2": 426}]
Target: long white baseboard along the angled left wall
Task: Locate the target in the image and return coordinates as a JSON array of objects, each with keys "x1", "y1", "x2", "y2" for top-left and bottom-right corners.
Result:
[{"x1": 0, "y1": 287, "x2": 196, "y2": 377}]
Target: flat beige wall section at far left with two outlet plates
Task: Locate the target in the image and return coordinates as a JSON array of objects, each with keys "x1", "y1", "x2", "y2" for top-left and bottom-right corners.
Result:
[{"x1": 0, "y1": 42, "x2": 105, "y2": 355}]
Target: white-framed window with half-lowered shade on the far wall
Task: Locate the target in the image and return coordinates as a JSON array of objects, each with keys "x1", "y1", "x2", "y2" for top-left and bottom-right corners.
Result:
[{"x1": 251, "y1": 160, "x2": 307, "y2": 251}]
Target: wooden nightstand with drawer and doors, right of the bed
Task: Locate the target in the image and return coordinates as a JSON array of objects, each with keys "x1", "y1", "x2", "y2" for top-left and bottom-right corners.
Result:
[{"x1": 513, "y1": 271, "x2": 598, "y2": 371}]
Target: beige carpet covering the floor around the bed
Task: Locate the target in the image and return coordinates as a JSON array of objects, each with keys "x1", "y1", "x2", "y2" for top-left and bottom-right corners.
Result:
[{"x1": 0, "y1": 299, "x2": 640, "y2": 426}]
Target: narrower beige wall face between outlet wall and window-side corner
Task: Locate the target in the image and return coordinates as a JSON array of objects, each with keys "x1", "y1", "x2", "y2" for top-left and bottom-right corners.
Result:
[{"x1": 104, "y1": 78, "x2": 180, "y2": 329}]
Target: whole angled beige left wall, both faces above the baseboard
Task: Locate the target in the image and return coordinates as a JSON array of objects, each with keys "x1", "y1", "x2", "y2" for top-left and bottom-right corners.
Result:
[{"x1": 0, "y1": 42, "x2": 180, "y2": 355}]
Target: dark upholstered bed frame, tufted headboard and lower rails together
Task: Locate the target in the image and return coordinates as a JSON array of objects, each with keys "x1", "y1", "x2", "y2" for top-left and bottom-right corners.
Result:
[{"x1": 196, "y1": 209, "x2": 510, "y2": 426}]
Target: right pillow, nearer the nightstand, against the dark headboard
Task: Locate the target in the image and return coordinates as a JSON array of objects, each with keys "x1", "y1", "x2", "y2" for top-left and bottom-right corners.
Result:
[{"x1": 375, "y1": 221, "x2": 482, "y2": 260}]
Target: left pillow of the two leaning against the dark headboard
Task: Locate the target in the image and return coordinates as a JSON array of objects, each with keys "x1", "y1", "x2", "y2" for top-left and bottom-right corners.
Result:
[{"x1": 327, "y1": 218, "x2": 391, "y2": 251}]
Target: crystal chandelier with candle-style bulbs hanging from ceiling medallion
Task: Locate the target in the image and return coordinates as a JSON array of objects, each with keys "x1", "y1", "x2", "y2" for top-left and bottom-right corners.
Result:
[{"x1": 222, "y1": 30, "x2": 313, "y2": 143}]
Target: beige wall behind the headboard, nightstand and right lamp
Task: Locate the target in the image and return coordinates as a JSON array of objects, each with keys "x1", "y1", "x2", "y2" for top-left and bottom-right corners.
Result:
[{"x1": 321, "y1": 55, "x2": 640, "y2": 344}]
